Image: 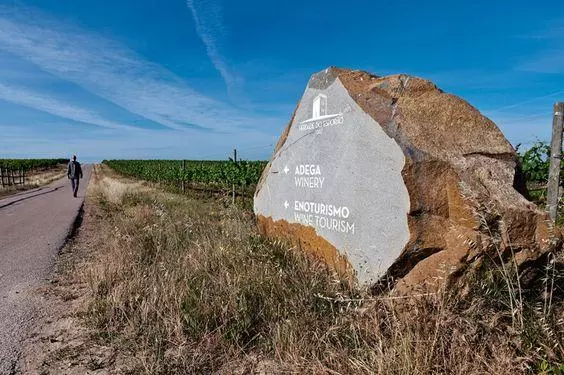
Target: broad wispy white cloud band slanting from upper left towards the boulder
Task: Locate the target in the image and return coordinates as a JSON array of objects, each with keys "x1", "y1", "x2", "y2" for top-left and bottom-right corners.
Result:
[{"x1": 0, "y1": 6, "x2": 278, "y2": 132}]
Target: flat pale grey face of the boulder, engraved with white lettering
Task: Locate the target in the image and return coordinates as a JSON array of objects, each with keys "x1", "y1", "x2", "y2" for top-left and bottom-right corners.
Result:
[{"x1": 254, "y1": 72, "x2": 410, "y2": 283}]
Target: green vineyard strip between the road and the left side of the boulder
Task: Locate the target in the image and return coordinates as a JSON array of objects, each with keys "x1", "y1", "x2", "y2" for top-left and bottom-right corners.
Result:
[{"x1": 103, "y1": 160, "x2": 267, "y2": 189}]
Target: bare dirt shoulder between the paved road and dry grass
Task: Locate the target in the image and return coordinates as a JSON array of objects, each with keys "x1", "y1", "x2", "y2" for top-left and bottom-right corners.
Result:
[{"x1": 20, "y1": 167, "x2": 132, "y2": 375}]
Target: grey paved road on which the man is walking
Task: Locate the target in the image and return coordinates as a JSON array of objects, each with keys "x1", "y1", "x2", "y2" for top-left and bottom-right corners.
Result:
[{"x1": 0, "y1": 166, "x2": 91, "y2": 375}]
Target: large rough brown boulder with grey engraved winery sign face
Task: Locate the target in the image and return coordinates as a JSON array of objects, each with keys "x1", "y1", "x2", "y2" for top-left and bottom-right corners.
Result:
[{"x1": 254, "y1": 68, "x2": 562, "y2": 288}]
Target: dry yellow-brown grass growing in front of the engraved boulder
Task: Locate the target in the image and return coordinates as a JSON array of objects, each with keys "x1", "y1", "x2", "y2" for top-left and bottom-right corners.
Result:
[{"x1": 47, "y1": 167, "x2": 564, "y2": 374}]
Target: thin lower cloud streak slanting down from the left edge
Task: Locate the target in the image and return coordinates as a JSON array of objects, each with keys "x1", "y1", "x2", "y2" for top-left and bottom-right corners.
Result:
[{"x1": 0, "y1": 83, "x2": 136, "y2": 130}]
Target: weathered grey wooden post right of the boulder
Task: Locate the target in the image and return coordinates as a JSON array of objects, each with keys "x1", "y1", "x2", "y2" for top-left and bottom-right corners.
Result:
[{"x1": 546, "y1": 102, "x2": 564, "y2": 221}]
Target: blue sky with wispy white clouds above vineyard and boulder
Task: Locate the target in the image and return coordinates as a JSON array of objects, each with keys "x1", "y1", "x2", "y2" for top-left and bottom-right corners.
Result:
[{"x1": 0, "y1": 0, "x2": 564, "y2": 161}]
